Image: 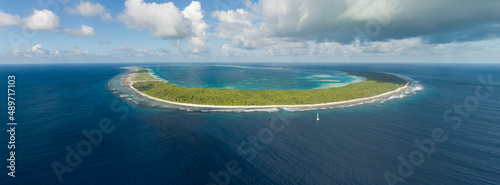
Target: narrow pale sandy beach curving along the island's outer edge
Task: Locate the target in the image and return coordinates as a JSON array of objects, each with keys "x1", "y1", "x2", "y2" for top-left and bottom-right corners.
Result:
[{"x1": 125, "y1": 67, "x2": 410, "y2": 109}]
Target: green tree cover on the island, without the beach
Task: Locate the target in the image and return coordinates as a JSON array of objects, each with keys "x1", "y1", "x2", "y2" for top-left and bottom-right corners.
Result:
[{"x1": 133, "y1": 67, "x2": 407, "y2": 106}]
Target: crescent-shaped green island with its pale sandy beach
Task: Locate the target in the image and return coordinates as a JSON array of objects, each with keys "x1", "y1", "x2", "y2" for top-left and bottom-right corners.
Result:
[{"x1": 125, "y1": 66, "x2": 409, "y2": 108}]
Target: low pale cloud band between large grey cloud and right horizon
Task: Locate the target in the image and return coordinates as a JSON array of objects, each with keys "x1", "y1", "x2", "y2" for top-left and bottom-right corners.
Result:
[{"x1": 213, "y1": 38, "x2": 500, "y2": 62}]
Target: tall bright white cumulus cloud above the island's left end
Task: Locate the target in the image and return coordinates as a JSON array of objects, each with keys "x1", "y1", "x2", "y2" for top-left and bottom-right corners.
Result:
[{"x1": 118, "y1": 0, "x2": 209, "y2": 53}]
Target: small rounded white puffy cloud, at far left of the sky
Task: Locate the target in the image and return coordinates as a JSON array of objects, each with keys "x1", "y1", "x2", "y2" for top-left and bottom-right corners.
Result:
[{"x1": 23, "y1": 9, "x2": 61, "y2": 30}]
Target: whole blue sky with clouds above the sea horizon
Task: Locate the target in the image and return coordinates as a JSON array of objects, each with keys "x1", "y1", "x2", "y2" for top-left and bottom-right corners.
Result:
[{"x1": 0, "y1": 0, "x2": 500, "y2": 63}]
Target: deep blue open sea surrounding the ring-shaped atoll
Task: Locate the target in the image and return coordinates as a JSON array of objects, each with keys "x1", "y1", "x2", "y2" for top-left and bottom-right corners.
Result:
[{"x1": 0, "y1": 63, "x2": 500, "y2": 185}]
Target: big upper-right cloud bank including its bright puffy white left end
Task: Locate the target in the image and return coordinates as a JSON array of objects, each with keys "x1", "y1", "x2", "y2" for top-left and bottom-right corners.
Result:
[{"x1": 216, "y1": 0, "x2": 500, "y2": 49}]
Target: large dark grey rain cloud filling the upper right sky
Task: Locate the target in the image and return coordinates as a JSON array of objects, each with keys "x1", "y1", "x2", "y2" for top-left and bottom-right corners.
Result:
[{"x1": 260, "y1": 0, "x2": 500, "y2": 43}]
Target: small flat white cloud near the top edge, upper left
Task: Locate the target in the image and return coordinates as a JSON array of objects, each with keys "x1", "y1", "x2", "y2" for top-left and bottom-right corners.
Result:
[{"x1": 64, "y1": 1, "x2": 113, "y2": 21}]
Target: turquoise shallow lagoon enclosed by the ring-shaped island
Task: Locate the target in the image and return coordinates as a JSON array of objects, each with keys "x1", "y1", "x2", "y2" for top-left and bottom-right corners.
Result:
[{"x1": 148, "y1": 65, "x2": 365, "y2": 90}]
